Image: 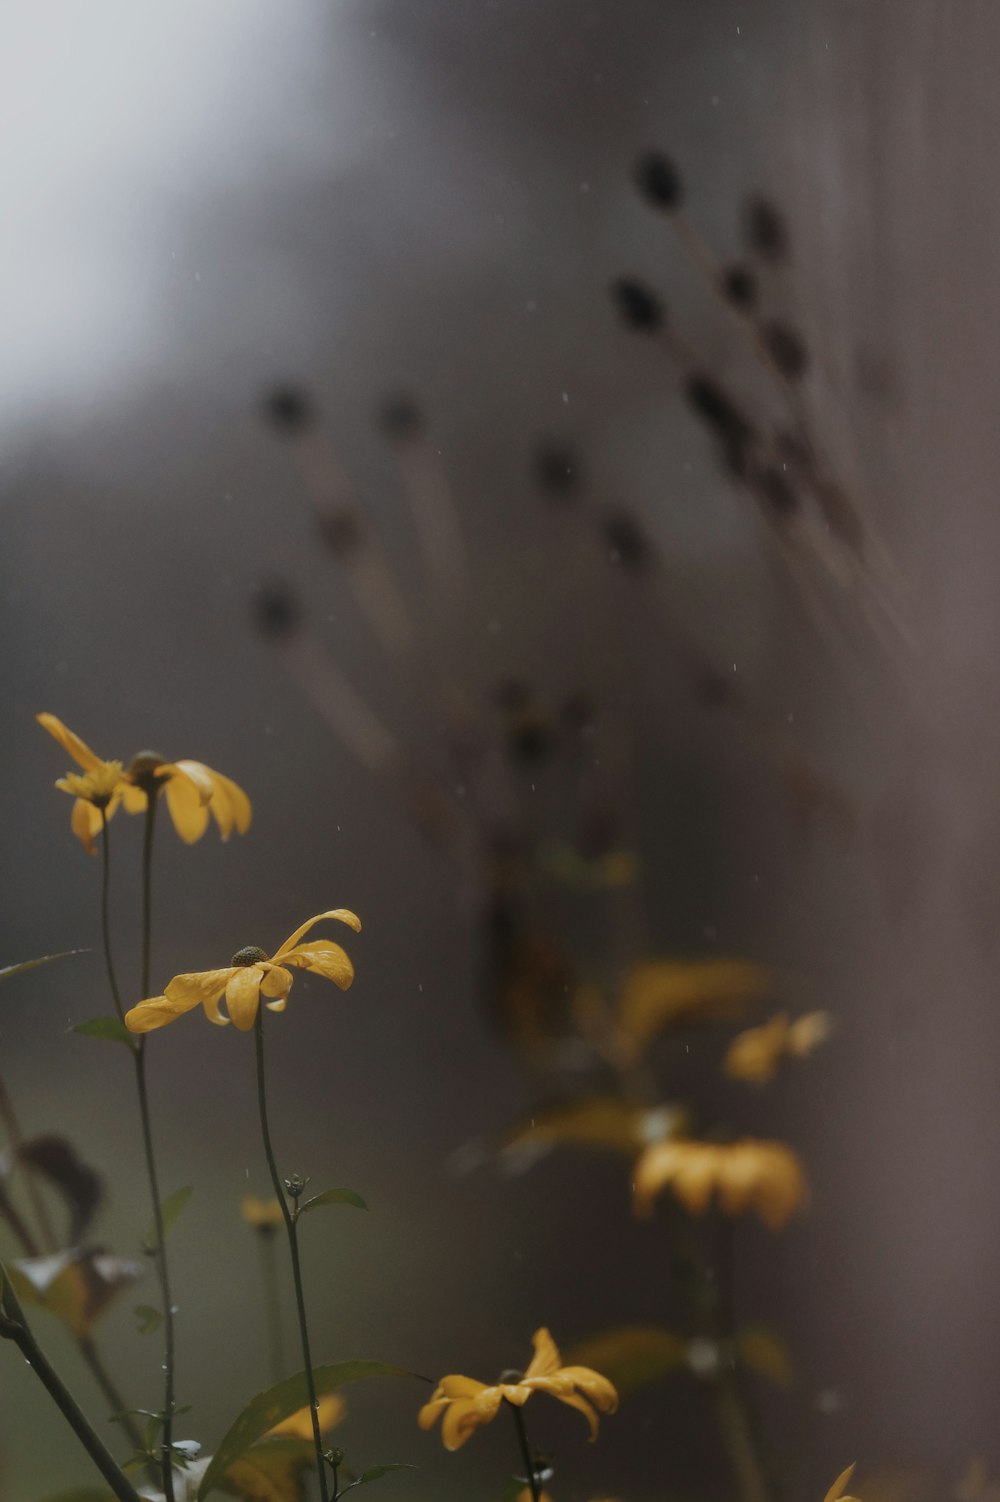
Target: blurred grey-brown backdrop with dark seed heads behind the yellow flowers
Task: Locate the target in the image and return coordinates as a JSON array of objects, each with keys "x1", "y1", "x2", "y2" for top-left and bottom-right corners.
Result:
[{"x1": 0, "y1": 0, "x2": 1000, "y2": 1502}]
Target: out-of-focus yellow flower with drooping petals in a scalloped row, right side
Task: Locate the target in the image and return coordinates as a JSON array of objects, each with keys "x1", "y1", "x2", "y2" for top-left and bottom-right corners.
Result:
[{"x1": 632, "y1": 1137, "x2": 808, "y2": 1230}]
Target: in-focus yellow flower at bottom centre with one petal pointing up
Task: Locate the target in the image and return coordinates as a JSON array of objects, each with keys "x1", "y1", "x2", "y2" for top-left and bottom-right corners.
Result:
[{"x1": 417, "y1": 1329, "x2": 619, "y2": 1449}]
